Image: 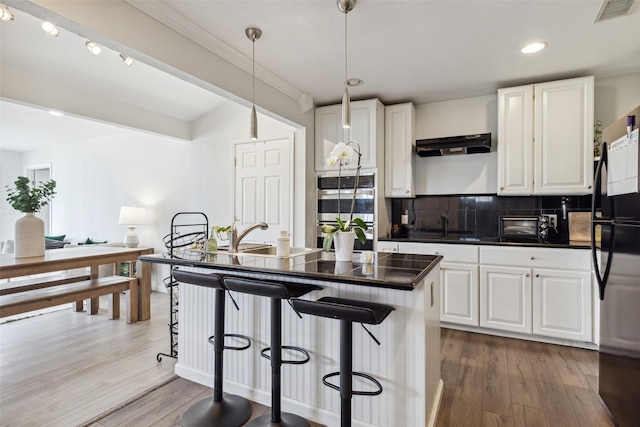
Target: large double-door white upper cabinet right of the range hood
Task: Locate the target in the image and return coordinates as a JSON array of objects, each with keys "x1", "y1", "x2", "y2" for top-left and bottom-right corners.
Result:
[{"x1": 498, "y1": 76, "x2": 593, "y2": 195}]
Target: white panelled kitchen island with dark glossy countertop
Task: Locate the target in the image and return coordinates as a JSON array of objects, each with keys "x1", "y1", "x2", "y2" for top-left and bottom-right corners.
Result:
[{"x1": 140, "y1": 250, "x2": 442, "y2": 427}]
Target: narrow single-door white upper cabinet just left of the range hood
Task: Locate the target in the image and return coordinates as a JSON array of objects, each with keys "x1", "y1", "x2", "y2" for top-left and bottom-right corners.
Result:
[{"x1": 384, "y1": 103, "x2": 416, "y2": 197}]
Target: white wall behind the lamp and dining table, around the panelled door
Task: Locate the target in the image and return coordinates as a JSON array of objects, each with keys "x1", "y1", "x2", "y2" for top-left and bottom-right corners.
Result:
[{"x1": 0, "y1": 102, "x2": 298, "y2": 288}]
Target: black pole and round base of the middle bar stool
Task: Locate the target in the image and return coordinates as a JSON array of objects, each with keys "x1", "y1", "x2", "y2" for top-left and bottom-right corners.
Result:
[{"x1": 247, "y1": 298, "x2": 310, "y2": 427}]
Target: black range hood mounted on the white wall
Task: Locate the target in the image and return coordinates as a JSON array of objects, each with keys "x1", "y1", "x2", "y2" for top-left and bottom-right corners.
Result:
[{"x1": 416, "y1": 133, "x2": 491, "y2": 157}]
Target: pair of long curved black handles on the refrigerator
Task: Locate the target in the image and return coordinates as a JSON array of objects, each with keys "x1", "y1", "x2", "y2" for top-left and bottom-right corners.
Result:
[{"x1": 591, "y1": 142, "x2": 616, "y2": 300}]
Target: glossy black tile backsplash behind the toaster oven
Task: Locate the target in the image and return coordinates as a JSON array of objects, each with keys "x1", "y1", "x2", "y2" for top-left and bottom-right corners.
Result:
[{"x1": 391, "y1": 194, "x2": 591, "y2": 243}]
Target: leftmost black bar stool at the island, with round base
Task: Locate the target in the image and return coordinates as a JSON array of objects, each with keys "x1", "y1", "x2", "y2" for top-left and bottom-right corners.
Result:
[{"x1": 173, "y1": 270, "x2": 252, "y2": 427}]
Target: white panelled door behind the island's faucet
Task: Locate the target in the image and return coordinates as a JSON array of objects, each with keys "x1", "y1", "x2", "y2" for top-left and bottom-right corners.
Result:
[{"x1": 234, "y1": 139, "x2": 293, "y2": 243}]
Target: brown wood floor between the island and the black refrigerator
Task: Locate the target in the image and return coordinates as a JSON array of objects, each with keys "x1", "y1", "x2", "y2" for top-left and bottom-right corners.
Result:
[{"x1": 437, "y1": 329, "x2": 613, "y2": 427}]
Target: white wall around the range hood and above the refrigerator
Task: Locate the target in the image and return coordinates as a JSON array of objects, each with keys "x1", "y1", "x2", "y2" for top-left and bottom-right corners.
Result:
[{"x1": 414, "y1": 73, "x2": 640, "y2": 195}]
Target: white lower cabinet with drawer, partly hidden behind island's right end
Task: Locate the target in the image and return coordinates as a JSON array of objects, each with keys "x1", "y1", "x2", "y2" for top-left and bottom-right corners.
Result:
[{"x1": 398, "y1": 242, "x2": 480, "y2": 326}]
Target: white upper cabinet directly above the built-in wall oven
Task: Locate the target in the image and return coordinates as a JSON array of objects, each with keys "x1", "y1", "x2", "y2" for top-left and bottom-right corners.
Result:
[{"x1": 315, "y1": 99, "x2": 384, "y2": 172}]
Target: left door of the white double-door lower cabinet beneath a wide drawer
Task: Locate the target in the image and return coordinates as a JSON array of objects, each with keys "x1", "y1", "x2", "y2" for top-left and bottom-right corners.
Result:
[{"x1": 480, "y1": 265, "x2": 532, "y2": 334}]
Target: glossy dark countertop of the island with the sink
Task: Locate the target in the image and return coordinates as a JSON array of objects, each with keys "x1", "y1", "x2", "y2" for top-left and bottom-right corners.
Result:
[{"x1": 138, "y1": 252, "x2": 442, "y2": 291}]
